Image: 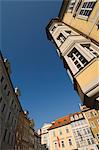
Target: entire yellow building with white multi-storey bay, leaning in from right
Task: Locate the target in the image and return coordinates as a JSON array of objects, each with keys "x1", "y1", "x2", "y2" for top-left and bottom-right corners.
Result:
[{"x1": 46, "y1": 0, "x2": 99, "y2": 109}]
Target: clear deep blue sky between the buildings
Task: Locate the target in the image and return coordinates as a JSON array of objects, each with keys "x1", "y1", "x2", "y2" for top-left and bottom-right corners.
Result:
[{"x1": 0, "y1": 0, "x2": 80, "y2": 128}]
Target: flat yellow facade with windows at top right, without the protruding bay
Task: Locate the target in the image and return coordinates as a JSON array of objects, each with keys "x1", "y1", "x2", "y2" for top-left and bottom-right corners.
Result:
[{"x1": 59, "y1": 0, "x2": 99, "y2": 42}]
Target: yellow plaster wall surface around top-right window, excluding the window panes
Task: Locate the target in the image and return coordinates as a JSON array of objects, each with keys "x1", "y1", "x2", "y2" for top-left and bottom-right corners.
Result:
[{"x1": 62, "y1": 0, "x2": 99, "y2": 42}]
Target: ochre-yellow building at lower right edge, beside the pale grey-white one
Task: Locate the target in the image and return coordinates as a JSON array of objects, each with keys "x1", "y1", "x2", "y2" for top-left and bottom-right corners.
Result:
[{"x1": 80, "y1": 106, "x2": 99, "y2": 146}]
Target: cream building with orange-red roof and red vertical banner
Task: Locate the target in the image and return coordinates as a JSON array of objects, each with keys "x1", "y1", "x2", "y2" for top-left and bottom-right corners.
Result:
[{"x1": 48, "y1": 115, "x2": 77, "y2": 150}]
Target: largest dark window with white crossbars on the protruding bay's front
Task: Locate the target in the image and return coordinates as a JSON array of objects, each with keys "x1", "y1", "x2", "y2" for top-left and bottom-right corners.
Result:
[{"x1": 68, "y1": 48, "x2": 88, "y2": 70}]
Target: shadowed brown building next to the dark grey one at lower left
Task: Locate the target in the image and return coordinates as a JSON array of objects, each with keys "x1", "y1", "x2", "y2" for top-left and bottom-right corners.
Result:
[{"x1": 15, "y1": 110, "x2": 35, "y2": 150}]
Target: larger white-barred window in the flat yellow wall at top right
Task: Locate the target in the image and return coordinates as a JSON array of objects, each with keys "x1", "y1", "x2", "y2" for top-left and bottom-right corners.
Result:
[{"x1": 79, "y1": 0, "x2": 96, "y2": 18}]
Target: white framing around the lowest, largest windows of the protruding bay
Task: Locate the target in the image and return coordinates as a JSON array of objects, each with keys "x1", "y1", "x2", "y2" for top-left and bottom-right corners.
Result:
[{"x1": 64, "y1": 42, "x2": 99, "y2": 75}]
